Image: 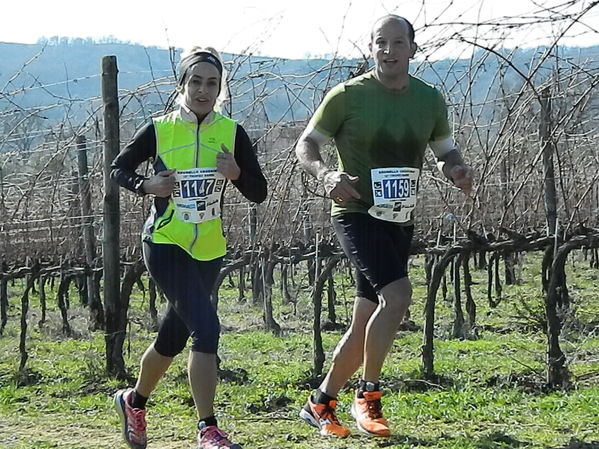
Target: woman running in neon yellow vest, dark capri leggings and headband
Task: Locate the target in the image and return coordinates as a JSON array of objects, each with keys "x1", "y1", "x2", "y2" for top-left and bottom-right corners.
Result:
[{"x1": 112, "y1": 47, "x2": 266, "y2": 449}]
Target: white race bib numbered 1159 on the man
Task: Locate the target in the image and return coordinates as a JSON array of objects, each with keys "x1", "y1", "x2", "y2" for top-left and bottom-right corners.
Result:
[{"x1": 368, "y1": 167, "x2": 420, "y2": 223}]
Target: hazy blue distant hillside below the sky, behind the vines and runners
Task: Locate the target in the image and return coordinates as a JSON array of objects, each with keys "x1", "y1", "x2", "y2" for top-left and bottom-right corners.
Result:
[{"x1": 0, "y1": 38, "x2": 599, "y2": 123}]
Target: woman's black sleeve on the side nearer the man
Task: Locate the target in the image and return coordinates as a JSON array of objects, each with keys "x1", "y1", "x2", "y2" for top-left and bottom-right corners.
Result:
[{"x1": 232, "y1": 125, "x2": 267, "y2": 203}]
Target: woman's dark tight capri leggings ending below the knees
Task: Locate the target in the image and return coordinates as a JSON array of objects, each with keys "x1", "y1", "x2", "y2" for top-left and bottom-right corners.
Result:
[{"x1": 143, "y1": 242, "x2": 223, "y2": 357}]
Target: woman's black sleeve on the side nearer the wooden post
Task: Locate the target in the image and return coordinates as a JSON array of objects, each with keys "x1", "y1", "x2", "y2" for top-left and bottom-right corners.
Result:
[{"x1": 110, "y1": 123, "x2": 156, "y2": 192}]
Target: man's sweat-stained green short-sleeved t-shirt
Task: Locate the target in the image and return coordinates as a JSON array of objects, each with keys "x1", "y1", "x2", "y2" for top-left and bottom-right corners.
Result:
[{"x1": 310, "y1": 72, "x2": 451, "y2": 215}]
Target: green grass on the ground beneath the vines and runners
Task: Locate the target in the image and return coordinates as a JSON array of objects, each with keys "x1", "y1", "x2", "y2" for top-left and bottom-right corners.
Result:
[{"x1": 0, "y1": 256, "x2": 599, "y2": 449}]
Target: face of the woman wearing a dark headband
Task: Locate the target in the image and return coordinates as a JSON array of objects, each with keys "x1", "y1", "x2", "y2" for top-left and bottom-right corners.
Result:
[{"x1": 183, "y1": 62, "x2": 220, "y2": 119}]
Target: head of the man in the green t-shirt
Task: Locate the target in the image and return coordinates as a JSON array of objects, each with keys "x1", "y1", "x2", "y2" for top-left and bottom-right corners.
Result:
[{"x1": 369, "y1": 19, "x2": 416, "y2": 78}]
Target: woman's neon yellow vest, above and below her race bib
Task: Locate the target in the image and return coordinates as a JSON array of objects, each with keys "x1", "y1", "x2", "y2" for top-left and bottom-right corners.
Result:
[{"x1": 152, "y1": 111, "x2": 237, "y2": 260}]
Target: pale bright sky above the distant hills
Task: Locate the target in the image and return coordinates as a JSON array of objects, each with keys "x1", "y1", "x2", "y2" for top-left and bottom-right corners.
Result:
[{"x1": 0, "y1": 0, "x2": 599, "y2": 58}]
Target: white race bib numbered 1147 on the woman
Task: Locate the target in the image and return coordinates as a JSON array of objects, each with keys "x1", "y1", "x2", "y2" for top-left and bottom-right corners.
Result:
[{"x1": 172, "y1": 168, "x2": 225, "y2": 223}]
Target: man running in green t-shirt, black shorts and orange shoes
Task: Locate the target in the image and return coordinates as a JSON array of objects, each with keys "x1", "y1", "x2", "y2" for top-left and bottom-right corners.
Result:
[{"x1": 296, "y1": 15, "x2": 472, "y2": 437}]
